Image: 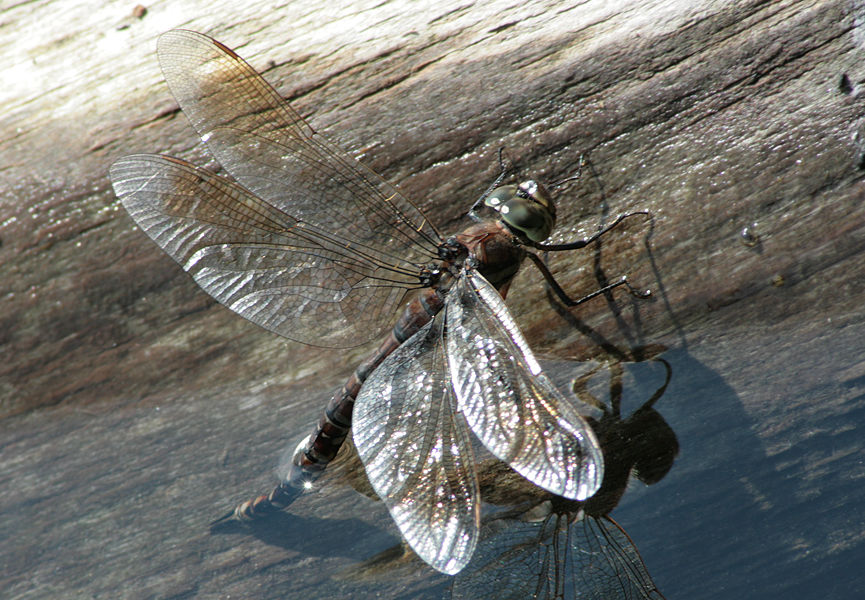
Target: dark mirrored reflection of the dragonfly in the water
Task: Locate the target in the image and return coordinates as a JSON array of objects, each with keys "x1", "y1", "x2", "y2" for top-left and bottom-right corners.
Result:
[{"x1": 450, "y1": 358, "x2": 679, "y2": 600}]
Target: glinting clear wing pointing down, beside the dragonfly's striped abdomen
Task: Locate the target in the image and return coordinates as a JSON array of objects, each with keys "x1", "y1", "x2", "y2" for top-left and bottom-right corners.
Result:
[{"x1": 352, "y1": 319, "x2": 480, "y2": 574}]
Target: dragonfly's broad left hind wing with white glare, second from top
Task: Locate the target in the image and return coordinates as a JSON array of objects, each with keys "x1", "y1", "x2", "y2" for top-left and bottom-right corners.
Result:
[{"x1": 111, "y1": 155, "x2": 418, "y2": 347}]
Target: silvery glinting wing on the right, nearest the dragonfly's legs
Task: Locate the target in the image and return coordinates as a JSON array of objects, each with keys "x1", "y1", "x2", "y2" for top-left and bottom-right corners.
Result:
[{"x1": 445, "y1": 270, "x2": 603, "y2": 500}]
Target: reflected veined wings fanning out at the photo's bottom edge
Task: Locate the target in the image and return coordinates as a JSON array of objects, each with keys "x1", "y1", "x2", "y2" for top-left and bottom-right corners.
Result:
[{"x1": 451, "y1": 513, "x2": 664, "y2": 600}]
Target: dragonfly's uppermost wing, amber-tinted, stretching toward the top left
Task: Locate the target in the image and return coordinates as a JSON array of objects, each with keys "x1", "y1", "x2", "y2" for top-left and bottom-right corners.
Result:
[{"x1": 158, "y1": 30, "x2": 440, "y2": 262}]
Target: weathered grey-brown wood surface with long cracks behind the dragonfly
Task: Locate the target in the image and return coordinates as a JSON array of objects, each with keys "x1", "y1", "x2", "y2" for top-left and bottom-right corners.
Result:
[{"x1": 0, "y1": 1, "x2": 865, "y2": 598}]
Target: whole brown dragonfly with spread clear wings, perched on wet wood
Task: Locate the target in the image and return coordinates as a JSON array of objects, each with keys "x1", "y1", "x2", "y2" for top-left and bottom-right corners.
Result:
[{"x1": 110, "y1": 30, "x2": 650, "y2": 574}]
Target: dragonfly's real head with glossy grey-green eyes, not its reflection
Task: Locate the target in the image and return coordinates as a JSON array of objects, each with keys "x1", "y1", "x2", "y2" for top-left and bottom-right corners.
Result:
[{"x1": 484, "y1": 179, "x2": 556, "y2": 242}]
